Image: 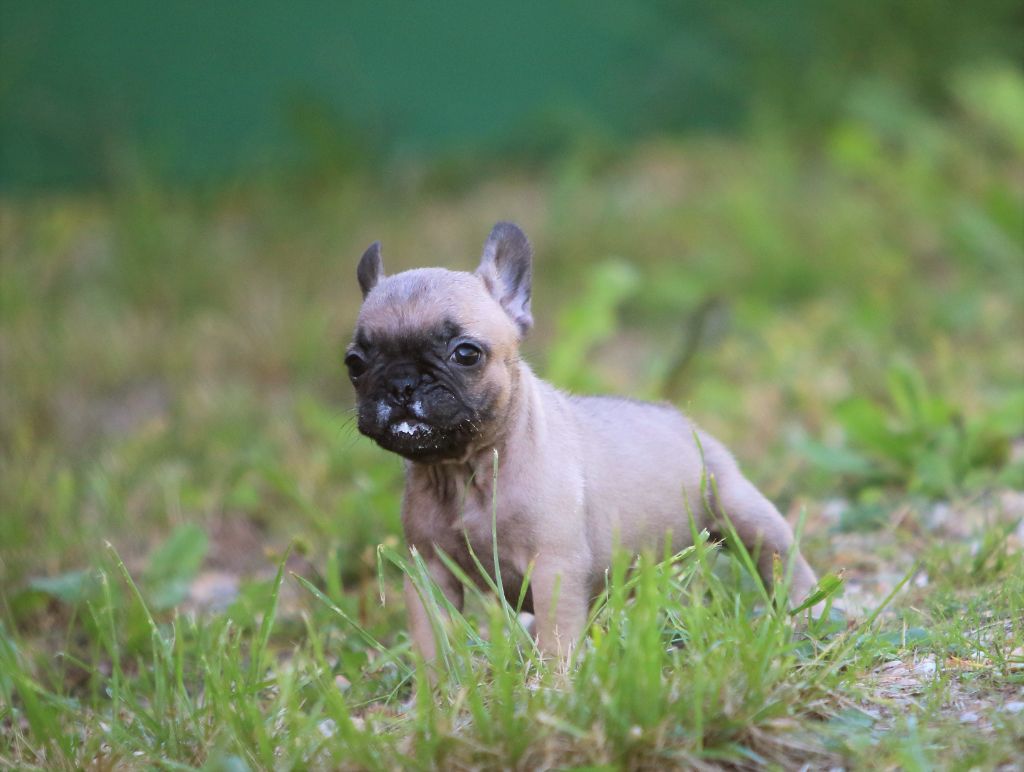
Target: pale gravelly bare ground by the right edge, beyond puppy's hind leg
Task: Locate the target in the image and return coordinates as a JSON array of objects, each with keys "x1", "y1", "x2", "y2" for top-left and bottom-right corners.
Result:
[{"x1": 822, "y1": 489, "x2": 1024, "y2": 745}]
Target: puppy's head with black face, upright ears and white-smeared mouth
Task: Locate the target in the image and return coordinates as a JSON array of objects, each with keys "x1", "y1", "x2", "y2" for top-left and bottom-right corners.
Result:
[{"x1": 345, "y1": 222, "x2": 532, "y2": 463}]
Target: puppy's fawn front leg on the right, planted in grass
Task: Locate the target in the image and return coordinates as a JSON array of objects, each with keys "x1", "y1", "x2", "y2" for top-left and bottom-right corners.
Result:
[{"x1": 530, "y1": 555, "x2": 589, "y2": 659}]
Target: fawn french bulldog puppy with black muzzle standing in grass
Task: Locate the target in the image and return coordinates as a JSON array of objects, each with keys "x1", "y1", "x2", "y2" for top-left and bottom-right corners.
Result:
[{"x1": 345, "y1": 222, "x2": 816, "y2": 660}]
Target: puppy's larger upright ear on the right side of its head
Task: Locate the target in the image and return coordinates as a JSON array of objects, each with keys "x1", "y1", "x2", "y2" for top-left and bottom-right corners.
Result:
[{"x1": 476, "y1": 222, "x2": 534, "y2": 337}]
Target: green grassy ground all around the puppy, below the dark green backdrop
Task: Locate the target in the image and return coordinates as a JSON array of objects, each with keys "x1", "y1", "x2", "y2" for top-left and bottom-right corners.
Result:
[{"x1": 0, "y1": 68, "x2": 1024, "y2": 769}]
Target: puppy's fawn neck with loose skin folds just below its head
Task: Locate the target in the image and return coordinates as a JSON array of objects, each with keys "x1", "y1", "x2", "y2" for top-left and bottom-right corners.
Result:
[{"x1": 407, "y1": 361, "x2": 543, "y2": 503}]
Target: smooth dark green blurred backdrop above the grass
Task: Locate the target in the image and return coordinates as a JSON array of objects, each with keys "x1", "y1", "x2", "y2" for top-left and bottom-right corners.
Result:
[{"x1": 0, "y1": 0, "x2": 1022, "y2": 189}]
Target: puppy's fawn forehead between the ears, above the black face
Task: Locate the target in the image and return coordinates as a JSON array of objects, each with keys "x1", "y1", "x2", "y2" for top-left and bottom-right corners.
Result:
[{"x1": 355, "y1": 268, "x2": 514, "y2": 345}]
